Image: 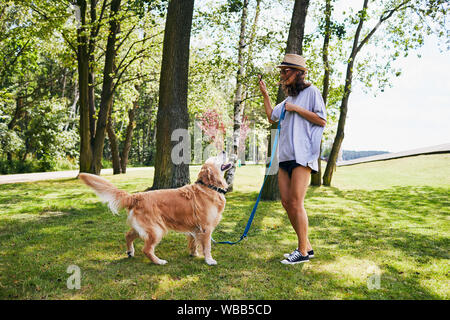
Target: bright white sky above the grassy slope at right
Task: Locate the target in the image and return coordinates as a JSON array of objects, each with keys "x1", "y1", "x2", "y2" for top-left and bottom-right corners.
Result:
[{"x1": 342, "y1": 38, "x2": 450, "y2": 152}]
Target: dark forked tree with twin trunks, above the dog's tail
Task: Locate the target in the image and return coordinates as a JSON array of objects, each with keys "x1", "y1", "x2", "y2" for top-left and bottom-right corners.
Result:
[{"x1": 73, "y1": 0, "x2": 121, "y2": 174}]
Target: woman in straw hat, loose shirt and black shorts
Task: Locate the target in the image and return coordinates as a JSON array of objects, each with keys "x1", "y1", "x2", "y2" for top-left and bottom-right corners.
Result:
[{"x1": 259, "y1": 54, "x2": 326, "y2": 264}]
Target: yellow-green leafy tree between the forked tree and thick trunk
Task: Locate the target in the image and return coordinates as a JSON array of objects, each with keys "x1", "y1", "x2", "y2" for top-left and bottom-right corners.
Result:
[{"x1": 105, "y1": 0, "x2": 166, "y2": 174}]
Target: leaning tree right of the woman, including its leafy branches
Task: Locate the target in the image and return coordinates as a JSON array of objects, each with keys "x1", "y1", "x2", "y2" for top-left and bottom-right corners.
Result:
[{"x1": 323, "y1": 0, "x2": 446, "y2": 186}]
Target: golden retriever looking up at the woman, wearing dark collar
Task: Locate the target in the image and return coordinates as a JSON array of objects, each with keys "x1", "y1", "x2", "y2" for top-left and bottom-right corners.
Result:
[{"x1": 79, "y1": 152, "x2": 231, "y2": 265}]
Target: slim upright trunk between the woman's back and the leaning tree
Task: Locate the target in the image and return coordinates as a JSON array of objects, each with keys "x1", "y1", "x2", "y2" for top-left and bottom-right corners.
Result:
[{"x1": 311, "y1": 0, "x2": 331, "y2": 187}]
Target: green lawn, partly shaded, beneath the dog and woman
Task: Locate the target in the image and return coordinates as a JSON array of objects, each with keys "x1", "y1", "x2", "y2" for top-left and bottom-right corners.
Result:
[{"x1": 0, "y1": 187, "x2": 449, "y2": 299}]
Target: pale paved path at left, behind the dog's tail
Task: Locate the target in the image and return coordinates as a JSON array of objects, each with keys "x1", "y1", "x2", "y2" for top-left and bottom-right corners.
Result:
[{"x1": 0, "y1": 167, "x2": 149, "y2": 184}]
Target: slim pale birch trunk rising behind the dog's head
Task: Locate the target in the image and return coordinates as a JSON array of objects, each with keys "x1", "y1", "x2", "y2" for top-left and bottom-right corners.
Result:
[{"x1": 225, "y1": 0, "x2": 248, "y2": 192}]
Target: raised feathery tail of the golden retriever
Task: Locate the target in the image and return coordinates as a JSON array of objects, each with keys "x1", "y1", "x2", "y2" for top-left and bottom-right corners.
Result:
[{"x1": 78, "y1": 173, "x2": 132, "y2": 214}]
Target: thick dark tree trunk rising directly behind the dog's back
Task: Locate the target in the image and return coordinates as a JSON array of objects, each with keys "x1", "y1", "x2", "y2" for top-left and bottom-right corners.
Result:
[{"x1": 151, "y1": 0, "x2": 194, "y2": 189}]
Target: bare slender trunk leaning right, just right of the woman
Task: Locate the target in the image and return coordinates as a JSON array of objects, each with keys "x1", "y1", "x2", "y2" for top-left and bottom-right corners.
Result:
[{"x1": 323, "y1": 0, "x2": 368, "y2": 186}]
